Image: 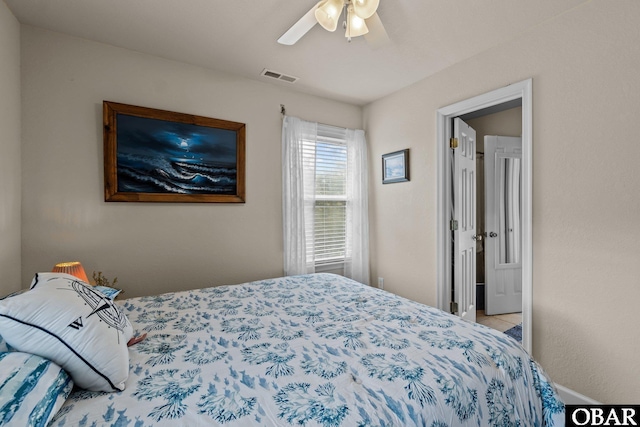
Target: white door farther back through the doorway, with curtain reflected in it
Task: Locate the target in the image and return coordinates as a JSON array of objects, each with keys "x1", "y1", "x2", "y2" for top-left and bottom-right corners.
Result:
[{"x1": 484, "y1": 136, "x2": 522, "y2": 315}]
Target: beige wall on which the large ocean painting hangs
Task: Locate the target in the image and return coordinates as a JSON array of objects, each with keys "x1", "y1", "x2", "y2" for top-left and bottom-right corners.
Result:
[{"x1": 22, "y1": 26, "x2": 362, "y2": 296}]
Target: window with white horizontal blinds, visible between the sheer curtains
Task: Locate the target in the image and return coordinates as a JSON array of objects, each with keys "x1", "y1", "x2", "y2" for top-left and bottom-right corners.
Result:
[{"x1": 303, "y1": 124, "x2": 347, "y2": 266}]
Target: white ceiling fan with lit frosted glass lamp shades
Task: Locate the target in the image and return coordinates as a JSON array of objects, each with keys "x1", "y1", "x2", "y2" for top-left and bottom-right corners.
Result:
[{"x1": 278, "y1": 0, "x2": 390, "y2": 49}]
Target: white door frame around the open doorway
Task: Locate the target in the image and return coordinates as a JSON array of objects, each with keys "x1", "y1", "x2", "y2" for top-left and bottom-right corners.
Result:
[{"x1": 436, "y1": 79, "x2": 533, "y2": 354}]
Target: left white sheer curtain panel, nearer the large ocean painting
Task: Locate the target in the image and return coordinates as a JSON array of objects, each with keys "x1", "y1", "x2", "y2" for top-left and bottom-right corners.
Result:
[{"x1": 282, "y1": 116, "x2": 318, "y2": 276}]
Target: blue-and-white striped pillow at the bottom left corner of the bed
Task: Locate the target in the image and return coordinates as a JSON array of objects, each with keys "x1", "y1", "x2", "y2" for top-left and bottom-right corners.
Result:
[{"x1": 0, "y1": 352, "x2": 73, "y2": 427}]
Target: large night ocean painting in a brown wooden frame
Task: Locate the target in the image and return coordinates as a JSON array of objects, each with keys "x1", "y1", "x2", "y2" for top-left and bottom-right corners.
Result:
[{"x1": 102, "y1": 101, "x2": 245, "y2": 203}]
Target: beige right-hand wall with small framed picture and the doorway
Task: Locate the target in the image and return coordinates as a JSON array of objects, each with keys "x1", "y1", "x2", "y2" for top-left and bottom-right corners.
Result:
[{"x1": 364, "y1": 0, "x2": 640, "y2": 403}]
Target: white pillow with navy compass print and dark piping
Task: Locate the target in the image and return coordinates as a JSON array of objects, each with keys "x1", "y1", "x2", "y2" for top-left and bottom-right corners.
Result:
[{"x1": 0, "y1": 273, "x2": 133, "y2": 391}]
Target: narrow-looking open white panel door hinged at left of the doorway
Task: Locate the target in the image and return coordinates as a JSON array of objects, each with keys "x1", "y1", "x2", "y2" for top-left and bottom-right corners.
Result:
[{"x1": 452, "y1": 118, "x2": 476, "y2": 322}]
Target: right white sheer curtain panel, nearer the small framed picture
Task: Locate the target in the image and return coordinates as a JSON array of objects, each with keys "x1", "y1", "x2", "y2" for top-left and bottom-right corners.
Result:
[{"x1": 344, "y1": 129, "x2": 369, "y2": 285}]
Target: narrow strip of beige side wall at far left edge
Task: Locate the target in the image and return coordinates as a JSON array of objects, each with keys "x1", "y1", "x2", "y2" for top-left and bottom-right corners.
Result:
[{"x1": 0, "y1": 0, "x2": 21, "y2": 296}]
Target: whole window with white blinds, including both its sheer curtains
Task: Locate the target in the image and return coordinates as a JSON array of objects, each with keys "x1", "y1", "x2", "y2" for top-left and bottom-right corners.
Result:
[{"x1": 282, "y1": 116, "x2": 369, "y2": 284}]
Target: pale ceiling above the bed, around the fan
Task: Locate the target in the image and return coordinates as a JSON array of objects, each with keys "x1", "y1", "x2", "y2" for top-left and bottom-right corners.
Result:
[{"x1": 5, "y1": 0, "x2": 588, "y2": 105}]
